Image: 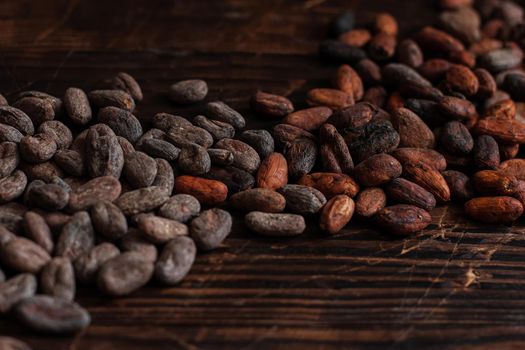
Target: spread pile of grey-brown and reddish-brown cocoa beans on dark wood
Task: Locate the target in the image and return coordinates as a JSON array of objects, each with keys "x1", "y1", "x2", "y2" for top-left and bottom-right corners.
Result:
[{"x1": 0, "y1": 0, "x2": 525, "y2": 349}]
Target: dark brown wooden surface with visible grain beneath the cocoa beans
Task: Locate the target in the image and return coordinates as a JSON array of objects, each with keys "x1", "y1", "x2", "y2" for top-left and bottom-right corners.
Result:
[{"x1": 0, "y1": 0, "x2": 525, "y2": 350}]
